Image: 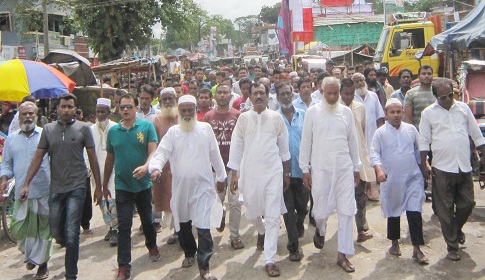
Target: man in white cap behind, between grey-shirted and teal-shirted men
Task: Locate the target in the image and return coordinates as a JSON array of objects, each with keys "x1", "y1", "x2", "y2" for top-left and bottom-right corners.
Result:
[{"x1": 84, "y1": 98, "x2": 118, "y2": 246}]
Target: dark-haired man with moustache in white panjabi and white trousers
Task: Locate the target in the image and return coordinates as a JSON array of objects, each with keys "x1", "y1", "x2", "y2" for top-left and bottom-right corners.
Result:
[{"x1": 227, "y1": 82, "x2": 291, "y2": 277}]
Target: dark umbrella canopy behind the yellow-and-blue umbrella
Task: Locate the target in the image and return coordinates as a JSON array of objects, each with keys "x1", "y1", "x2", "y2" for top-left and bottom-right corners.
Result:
[{"x1": 44, "y1": 50, "x2": 97, "y2": 87}]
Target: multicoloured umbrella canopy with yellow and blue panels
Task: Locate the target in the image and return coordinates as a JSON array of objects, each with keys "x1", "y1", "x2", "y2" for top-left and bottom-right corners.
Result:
[{"x1": 0, "y1": 59, "x2": 76, "y2": 102}]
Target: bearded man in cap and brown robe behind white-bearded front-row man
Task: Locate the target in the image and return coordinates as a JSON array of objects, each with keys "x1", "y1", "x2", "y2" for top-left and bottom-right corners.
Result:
[{"x1": 152, "y1": 87, "x2": 178, "y2": 244}]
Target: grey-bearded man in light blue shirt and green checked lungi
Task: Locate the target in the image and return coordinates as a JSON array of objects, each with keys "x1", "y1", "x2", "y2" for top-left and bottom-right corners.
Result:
[{"x1": 0, "y1": 101, "x2": 52, "y2": 279}]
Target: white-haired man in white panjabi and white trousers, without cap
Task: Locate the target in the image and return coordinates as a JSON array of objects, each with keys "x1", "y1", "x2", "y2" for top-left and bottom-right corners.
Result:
[{"x1": 299, "y1": 77, "x2": 361, "y2": 272}]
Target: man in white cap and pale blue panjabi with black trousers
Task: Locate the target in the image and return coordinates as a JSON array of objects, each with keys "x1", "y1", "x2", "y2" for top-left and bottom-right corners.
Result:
[{"x1": 370, "y1": 98, "x2": 428, "y2": 264}]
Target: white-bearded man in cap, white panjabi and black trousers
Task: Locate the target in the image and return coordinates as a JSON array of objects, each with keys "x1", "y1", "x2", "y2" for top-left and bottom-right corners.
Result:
[{"x1": 149, "y1": 95, "x2": 226, "y2": 279}]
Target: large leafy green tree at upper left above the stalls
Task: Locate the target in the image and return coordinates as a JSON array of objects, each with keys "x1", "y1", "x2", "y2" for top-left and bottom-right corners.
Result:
[{"x1": 74, "y1": 0, "x2": 186, "y2": 61}]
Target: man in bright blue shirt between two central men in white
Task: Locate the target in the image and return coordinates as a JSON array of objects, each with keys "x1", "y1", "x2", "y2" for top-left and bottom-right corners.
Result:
[{"x1": 276, "y1": 83, "x2": 310, "y2": 261}]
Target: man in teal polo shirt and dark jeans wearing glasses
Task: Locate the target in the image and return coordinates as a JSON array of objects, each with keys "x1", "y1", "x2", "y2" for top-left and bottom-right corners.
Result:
[{"x1": 101, "y1": 94, "x2": 160, "y2": 280}]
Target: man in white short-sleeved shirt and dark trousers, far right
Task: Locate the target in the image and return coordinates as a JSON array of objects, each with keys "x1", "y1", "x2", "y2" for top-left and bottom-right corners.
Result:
[{"x1": 419, "y1": 78, "x2": 485, "y2": 261}]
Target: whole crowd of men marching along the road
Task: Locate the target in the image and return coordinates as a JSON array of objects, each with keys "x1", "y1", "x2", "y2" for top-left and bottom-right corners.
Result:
[{"x1": 0, "y1": 60, "x2": 485, "y2": 280}]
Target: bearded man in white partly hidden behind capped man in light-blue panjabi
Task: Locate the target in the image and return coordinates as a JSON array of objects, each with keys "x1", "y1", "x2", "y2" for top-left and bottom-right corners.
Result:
[{"x1": 352, "y1": 73, "x2": 385, "y2": 201}]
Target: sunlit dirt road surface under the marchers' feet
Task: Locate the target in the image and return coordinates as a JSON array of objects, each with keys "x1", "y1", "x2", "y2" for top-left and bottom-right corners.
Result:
[{"x1": 0, "y1": 185, "x2": 485, "y2": 280}]
